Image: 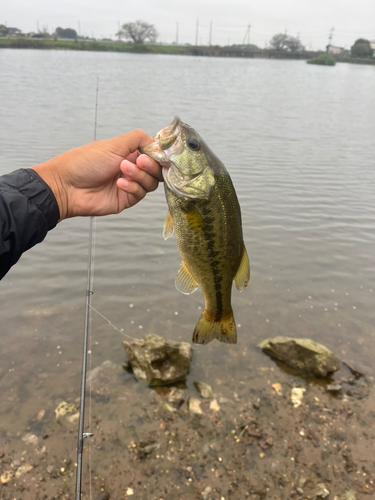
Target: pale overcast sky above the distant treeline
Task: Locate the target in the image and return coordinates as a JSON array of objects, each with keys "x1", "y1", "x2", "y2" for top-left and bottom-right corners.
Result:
[{"x1": 0, "y1": 0, "x2": 375, "y2": 49}]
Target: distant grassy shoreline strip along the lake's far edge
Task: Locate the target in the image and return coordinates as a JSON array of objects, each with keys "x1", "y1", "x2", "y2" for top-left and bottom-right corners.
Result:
[{"x1": 0, "y1": 38, "x2": 375, "y2": 65}]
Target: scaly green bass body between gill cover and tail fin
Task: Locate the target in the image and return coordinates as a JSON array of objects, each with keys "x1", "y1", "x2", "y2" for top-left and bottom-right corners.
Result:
[{"x1": 165, "y1": 170, "x2": 243, "y2": 321}]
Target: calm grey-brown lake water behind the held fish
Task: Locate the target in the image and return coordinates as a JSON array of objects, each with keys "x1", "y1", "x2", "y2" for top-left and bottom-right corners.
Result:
[{"x1": 0, "y1": 50, "x2": 375, "y2": 435}]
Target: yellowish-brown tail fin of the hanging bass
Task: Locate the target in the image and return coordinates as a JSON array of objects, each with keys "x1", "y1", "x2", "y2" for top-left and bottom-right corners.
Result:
[{"x1": 193, "y1": 309, "x2": 237, "y2": 344}]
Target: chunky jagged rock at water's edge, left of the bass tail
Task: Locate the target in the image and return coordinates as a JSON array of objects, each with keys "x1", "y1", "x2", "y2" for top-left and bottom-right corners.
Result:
[{"x1": 122, "y1": 334, "x2": 194, "y2": 385}]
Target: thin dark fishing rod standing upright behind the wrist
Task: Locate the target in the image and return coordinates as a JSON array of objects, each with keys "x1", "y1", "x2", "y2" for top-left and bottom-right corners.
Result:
[{"x1": 76, "y1": 77, "x2": 99, "y2": 500}]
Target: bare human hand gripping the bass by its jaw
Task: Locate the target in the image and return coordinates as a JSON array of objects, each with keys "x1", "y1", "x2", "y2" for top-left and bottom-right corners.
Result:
[{"x1": 31, "y1": 129, "x2": 162, "y2": 220}]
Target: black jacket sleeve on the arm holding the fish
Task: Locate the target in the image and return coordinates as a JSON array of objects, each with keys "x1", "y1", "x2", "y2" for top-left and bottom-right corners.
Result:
[{"x1": 0, "y1": 169, "x2": 60, "y2": 279}]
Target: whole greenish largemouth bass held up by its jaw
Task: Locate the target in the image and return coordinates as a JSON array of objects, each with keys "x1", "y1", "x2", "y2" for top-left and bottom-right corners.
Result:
[{"x1": 140, "y1": 116, "x2": 250, "y2": 344}]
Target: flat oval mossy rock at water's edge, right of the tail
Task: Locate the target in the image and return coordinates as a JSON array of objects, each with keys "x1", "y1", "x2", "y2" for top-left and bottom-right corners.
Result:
[{"x1": 259, "y1": 337, "x2": 340, "y2": 378}]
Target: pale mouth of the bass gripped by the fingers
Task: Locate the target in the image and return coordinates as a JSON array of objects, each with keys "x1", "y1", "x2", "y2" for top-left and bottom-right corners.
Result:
[{"x1": 139, "y1": 116, "x2": 183, "y2": 167}]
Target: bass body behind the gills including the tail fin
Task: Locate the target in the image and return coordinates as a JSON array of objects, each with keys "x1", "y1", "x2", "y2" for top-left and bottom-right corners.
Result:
[{"x1": 166, "y1": 182, "x2": 243, "y2": 344}]
